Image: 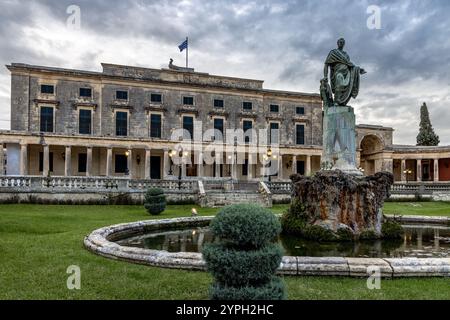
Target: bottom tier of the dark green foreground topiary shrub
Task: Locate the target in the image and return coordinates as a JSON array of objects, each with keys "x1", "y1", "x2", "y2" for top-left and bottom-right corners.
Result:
[{"x1": 211, "y1": 277, "x2": 287, "y2": 301}]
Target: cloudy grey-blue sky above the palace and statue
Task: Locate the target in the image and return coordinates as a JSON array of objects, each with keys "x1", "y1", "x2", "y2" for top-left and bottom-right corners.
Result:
[{"x1": 0, "y1": 0, "x2": 450, "y2": 144}]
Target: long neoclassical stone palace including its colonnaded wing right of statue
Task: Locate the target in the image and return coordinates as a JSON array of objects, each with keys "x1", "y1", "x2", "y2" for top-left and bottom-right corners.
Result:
[{"x1": 0, "y1": 63, "x2": 450, "y2": 182}]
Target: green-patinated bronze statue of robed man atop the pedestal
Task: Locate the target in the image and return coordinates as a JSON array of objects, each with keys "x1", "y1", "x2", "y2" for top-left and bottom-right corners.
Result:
[{"x1": 320, "y1": 38, "x2": 366, "y2": 107}]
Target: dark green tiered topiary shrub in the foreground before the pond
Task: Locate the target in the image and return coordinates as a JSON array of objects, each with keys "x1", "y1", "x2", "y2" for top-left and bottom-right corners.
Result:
[{"x1": 203, "y1": 204, "x2": 286, "y2": 300}]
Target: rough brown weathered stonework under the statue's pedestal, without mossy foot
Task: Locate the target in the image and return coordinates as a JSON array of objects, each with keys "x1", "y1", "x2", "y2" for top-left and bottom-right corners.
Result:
[{"x1": 290, "y1": 170, "x2": 393, "y2": 236}]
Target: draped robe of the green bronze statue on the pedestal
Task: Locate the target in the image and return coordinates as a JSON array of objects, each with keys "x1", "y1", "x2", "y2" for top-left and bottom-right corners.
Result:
[{"x1": 325, "y1": 49, "x2": 360, "y2": 106}]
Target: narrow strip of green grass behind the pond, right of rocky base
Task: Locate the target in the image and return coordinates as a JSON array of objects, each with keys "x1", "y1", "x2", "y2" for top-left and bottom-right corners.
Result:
[{"x1": 384, "y1": 202, "x2": 450, "y2": 217}]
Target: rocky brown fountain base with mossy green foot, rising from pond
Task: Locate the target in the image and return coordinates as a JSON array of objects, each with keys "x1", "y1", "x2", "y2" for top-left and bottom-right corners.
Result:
[{"x1": 282, "y1": 170, "x2": 402, "y2": 241}]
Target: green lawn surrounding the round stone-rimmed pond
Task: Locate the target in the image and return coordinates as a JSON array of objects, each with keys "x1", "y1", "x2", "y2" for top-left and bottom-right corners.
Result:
[{"x1": 0, "y1": 203, "x2": 450, "y2": 300}]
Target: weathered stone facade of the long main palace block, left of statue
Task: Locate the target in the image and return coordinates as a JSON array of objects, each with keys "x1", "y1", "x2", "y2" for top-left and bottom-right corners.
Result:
[{"x1": 0, "y1": 64, "x2": 322, "y2": 181}]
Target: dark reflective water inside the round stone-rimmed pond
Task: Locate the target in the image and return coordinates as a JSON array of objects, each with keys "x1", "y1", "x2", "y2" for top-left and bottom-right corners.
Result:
[{"x1": 116, "y1": 225, "x2": 450, "y2": 258}]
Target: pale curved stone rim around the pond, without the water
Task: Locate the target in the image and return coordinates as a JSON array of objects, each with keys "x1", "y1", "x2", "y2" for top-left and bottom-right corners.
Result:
[{"x1": 84, "y1": 217, "x2": 450, "y2": 278}]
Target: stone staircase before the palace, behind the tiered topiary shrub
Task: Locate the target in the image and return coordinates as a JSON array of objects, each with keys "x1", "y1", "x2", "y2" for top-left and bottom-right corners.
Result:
[{"x1": 199, "y1": 181, "x2": 272, "y2": 208}]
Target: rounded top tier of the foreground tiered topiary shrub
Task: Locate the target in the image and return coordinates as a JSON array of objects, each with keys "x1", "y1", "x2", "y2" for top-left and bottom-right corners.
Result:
[{"x1": 211, "y1": 204, "x2": 281, "y2": 248}]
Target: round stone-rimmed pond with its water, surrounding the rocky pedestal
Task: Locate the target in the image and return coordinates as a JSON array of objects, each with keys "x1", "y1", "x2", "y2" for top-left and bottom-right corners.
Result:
[{"x1": 84, "y1": 216, "x2": 450, "y2": 278}]
